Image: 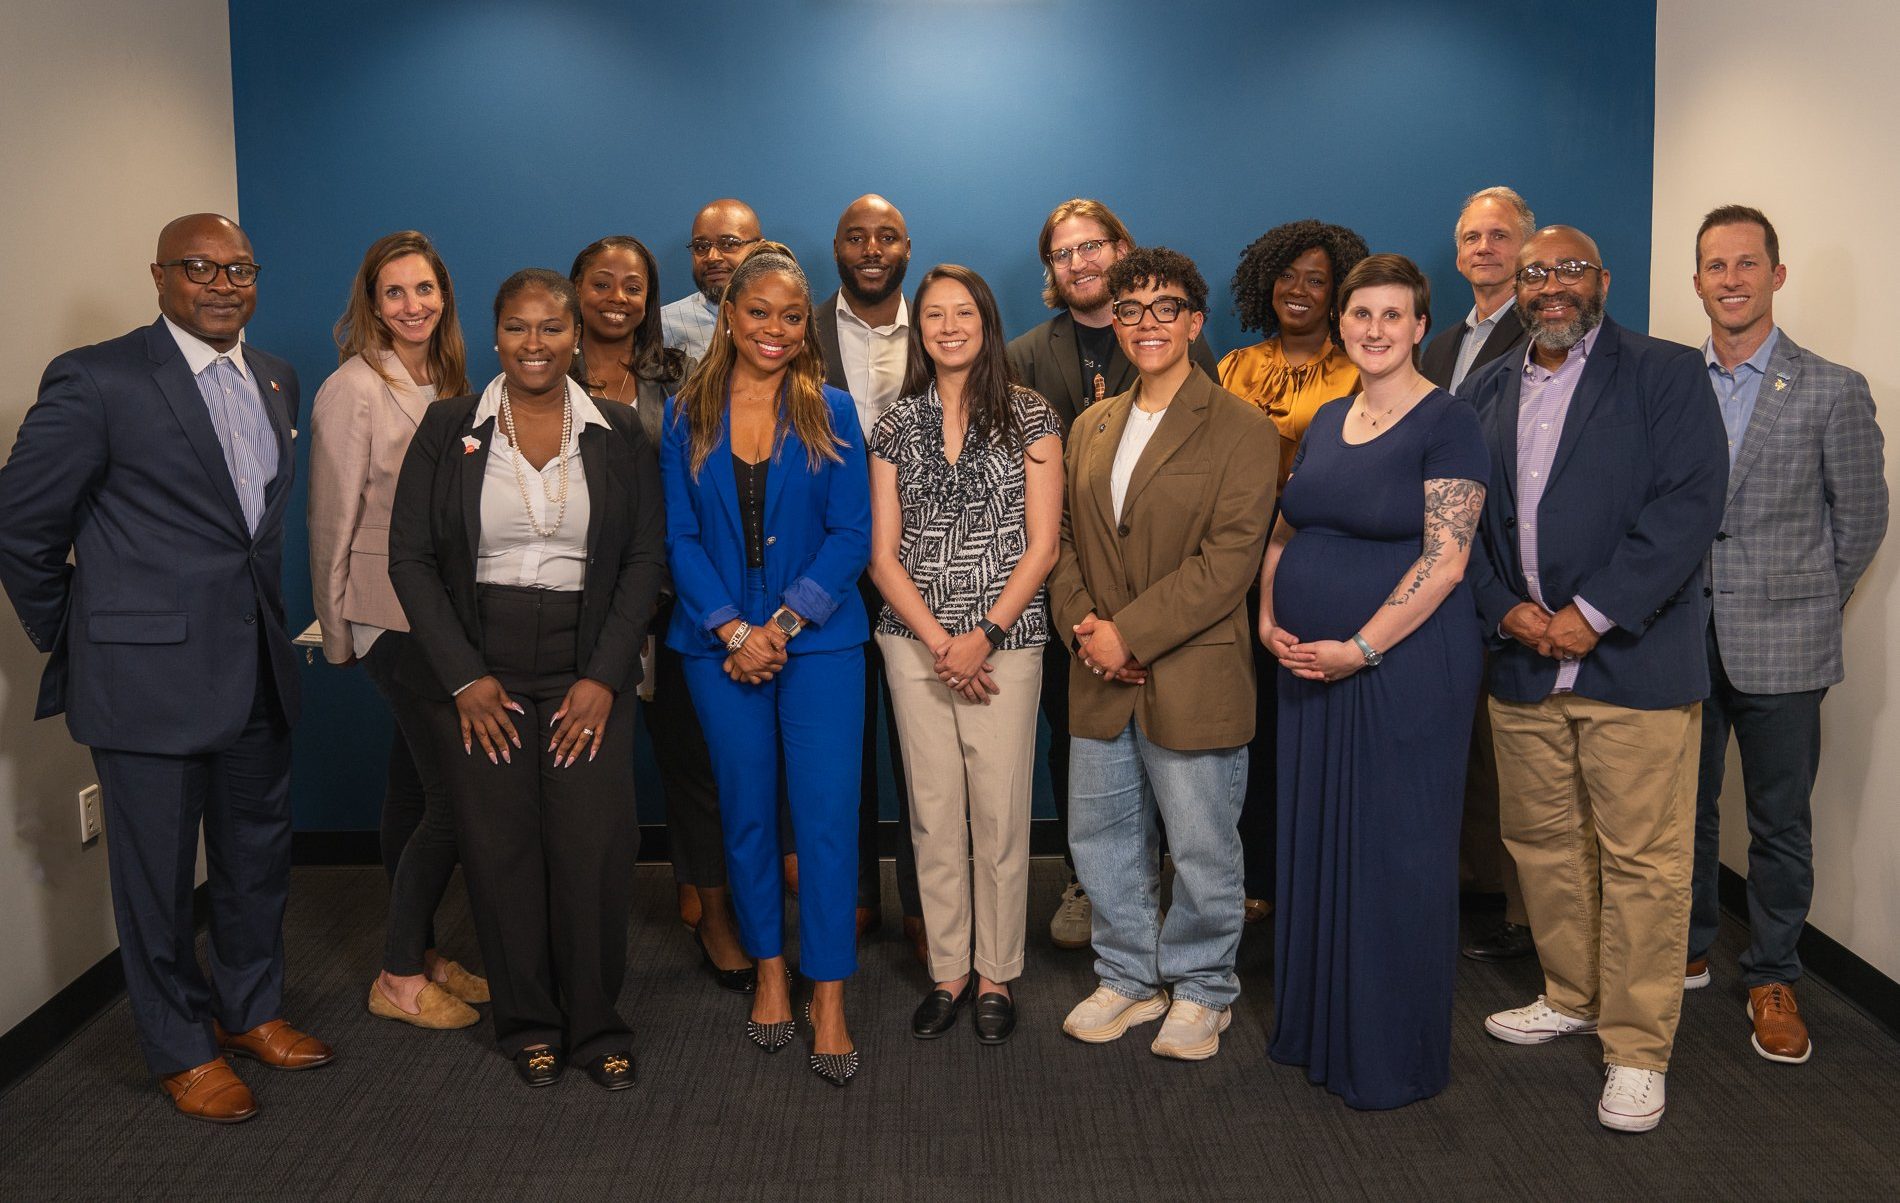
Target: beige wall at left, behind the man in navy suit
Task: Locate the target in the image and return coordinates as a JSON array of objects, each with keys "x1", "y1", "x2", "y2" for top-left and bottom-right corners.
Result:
[{"x1": 0, "y1": 0, "x2": 238, "y2": 1032}]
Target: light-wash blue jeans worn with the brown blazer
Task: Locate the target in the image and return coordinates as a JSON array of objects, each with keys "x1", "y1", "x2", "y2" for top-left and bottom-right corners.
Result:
[{"x1": 1068, "y1": 722, "x2": 1246, "y2": 1011}]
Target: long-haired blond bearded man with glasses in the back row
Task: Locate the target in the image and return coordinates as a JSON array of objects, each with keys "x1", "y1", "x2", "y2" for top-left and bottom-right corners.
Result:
[{"x1": 1007, "y1": 198, "x2": 1220, "y2": 948}]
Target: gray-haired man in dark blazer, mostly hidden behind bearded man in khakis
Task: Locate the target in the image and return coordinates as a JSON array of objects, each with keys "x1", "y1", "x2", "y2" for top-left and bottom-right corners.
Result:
[{"x1": 1419, "y1": 186, "x2": 1537, "y2": 962}]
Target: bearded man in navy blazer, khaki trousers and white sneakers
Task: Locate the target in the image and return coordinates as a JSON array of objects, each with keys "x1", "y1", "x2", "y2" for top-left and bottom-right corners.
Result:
[{"x1": 1467, "y1": 226, "x2": 1727, "y2": 1133}]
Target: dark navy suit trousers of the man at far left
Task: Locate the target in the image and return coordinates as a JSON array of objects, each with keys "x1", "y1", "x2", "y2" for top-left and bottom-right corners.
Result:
[{"x1": 93, "y1": 672, "x2": 291, "y2": 1076}]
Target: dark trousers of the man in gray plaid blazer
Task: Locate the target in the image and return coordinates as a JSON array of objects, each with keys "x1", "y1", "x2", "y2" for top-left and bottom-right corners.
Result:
[{"x1": 1689, "y1": 623, "x2": 1828, "y2": 986}]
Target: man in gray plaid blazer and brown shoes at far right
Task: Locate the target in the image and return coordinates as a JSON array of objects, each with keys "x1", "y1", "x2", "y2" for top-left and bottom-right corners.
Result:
[{"x1": 1683, "y1": 205, "x2": 1887, "y2": 1064}]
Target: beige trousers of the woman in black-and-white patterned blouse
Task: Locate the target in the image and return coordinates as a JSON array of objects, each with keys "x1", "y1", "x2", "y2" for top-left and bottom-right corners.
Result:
[{"x1": 878, "y1": 635, "x2": 1043, "y2": 983}]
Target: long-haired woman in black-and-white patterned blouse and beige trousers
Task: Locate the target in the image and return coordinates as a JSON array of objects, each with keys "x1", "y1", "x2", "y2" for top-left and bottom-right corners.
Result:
[{"x1": 870, "y1": 264, "x2": 1062, "y2": 1043}]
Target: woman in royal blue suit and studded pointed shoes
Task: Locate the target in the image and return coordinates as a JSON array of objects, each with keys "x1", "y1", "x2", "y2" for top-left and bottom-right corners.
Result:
[{"x1": 661, "y1": 243, "x2": 870, "y2": 1085}]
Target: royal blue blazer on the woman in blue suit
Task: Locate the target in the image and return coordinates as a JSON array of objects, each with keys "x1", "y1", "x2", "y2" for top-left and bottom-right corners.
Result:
[{"x1": 659, "y1": 386, "x2": 870, "y2": 658}]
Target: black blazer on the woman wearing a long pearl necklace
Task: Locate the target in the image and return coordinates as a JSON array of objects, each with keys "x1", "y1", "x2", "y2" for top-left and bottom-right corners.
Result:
[{"x1": 390, "y1": 389, "x2": 667, "y2": 697}]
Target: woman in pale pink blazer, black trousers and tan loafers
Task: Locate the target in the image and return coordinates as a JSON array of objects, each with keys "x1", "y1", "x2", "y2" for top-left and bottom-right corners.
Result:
[{"x1": 310, "y1": 230, "x2": 488, "y2": 1028}]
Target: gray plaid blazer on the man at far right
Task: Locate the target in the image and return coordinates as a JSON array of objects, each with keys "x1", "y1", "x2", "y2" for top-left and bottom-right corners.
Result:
[{"x1": 1708, "y1": 331, "x2": 1887, "y2": 694}]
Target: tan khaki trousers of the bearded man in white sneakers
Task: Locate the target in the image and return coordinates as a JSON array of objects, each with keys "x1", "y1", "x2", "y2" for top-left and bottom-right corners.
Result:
[{"x1": 1492, "y1": 694, "x2": 1702, "y2": 1070}]
